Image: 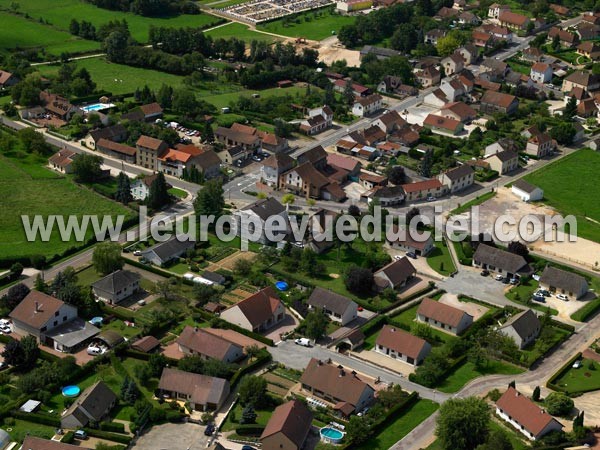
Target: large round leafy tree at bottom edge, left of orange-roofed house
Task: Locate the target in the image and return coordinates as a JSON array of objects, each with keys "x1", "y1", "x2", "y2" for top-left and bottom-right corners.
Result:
[{"x1": 435, "y1": 397, "x2": 490, "y2": 450}]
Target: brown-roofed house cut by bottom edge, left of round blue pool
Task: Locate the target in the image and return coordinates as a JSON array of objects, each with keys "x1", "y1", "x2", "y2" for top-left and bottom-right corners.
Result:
[{"x1": 260, "y1": 399, "x2": 313, "y2": 450}]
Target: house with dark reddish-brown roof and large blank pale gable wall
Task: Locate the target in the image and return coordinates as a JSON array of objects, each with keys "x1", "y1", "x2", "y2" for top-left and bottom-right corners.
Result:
[{"x1": 221, "y1": 287, "x2": 285, "y2": 333}]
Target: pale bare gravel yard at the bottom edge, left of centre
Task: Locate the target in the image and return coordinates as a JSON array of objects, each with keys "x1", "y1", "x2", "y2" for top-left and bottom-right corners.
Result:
[{"x1": 132, "y1": 423, "x2": 208, "y2": 450}]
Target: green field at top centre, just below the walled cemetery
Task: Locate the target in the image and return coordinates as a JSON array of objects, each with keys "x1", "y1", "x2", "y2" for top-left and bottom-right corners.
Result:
[{"x1": 258, "y1": 8, "x2": 356, "y2": 41}]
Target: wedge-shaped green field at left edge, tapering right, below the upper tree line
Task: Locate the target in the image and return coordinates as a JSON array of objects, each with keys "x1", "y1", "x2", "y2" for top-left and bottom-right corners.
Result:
[{"x1": 0, "y1": 10, "x2": 100, "y2": 56}]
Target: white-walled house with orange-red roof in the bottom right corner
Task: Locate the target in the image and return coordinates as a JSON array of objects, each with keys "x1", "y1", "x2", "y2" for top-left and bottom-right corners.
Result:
[{"x1": 496, "y1": 386, "x2": 563, "y2": 441}]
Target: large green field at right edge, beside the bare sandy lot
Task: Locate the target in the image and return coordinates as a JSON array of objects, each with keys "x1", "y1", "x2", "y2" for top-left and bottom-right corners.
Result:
[{"x1": 525, "y1": 149, "x2": 600, "y2": 242}]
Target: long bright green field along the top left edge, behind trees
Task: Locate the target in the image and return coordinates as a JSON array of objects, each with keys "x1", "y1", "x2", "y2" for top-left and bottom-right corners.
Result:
[{"x1": 0, "y1": 0, "x2": 224, "y2": 42}]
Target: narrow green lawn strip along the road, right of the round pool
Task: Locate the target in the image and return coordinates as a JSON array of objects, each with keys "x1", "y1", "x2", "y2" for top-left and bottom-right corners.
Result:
[{"x1": 354, "y1": 399, "x2": 439, "y2": 450}]
